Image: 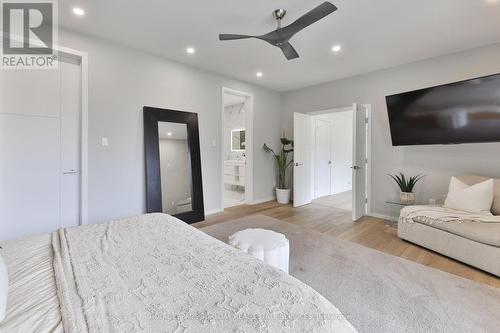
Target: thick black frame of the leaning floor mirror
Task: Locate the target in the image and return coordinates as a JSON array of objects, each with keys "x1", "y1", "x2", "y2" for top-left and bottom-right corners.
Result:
[{"x1": 143, "y1": 106, "x2": 205, "y2": 223}]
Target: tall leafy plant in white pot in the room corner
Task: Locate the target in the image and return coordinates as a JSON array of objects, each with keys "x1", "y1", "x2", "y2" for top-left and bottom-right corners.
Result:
[{"x1": 264, "y1": 138, "x2": 293, "y2": 204}]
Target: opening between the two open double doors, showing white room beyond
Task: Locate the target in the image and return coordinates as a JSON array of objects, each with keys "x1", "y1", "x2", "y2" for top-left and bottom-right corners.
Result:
[{"x1": 313, "y1": 108, "x2": 353, "y2": 211}]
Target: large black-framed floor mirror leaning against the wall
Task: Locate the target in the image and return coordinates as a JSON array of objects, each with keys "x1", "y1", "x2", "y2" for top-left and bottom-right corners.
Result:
[{"x1": 144, "y1": 107, "x2": 205, "y2": 223}]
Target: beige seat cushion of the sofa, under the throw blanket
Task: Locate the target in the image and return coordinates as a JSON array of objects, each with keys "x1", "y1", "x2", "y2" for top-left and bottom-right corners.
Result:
[{"x1": 413, "y1": 217, "x2": 500, "y2": 247}]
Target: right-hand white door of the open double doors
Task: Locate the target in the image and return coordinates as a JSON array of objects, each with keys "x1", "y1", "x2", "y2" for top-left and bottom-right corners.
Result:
[{"x1": 352, "y1": 104, "x2": 367, "y2": 221}]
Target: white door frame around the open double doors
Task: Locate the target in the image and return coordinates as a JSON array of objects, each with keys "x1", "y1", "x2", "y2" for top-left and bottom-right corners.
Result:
[{"x1": 306, "y1": 103, "x2": 372, "y2": 215}]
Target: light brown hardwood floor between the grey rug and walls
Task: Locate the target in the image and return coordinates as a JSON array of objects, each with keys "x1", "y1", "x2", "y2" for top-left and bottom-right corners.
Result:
[{"x1": 193, "y1": 202, "x2": 500, "y2": 288}]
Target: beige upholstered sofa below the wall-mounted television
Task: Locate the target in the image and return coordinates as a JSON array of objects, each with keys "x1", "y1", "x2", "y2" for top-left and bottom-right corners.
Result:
[{"x1": 398, "y1": 176, "x2": 500, "y2": 276}]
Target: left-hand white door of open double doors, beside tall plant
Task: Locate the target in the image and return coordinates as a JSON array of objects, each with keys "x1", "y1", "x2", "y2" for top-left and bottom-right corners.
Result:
[{"x1": 293, "y1": 112, "x2": 314, "y2": 207}]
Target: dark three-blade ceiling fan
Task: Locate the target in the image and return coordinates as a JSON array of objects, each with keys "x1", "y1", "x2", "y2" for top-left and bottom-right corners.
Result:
[{"x1": 219, "y1": 1, "x2": 337, "y2": 60}]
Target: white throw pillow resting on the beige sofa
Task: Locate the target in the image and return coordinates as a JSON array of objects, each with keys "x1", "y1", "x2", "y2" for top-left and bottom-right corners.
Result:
[{"x1": 444, "y1": 177, "x2": 495, "y2": 215}]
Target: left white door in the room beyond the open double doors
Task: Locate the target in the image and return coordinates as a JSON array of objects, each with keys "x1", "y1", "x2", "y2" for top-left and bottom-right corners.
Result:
[{"x1": 314, "y1": 119, "x2": 332, "y2": 198}]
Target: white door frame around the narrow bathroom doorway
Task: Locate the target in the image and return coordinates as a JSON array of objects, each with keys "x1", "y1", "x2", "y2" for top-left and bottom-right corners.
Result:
[{"x1": 220, "y1": 87, "x2": 254, "y2": 211}]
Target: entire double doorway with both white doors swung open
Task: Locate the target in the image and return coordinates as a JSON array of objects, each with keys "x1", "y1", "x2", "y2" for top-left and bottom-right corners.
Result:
[{"x1": 293, "y1": 104, "x2": 370, "y2": 221}]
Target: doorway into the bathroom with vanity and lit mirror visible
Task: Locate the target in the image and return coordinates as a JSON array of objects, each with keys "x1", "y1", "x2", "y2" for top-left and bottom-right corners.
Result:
[{"x1": 222, "y1": 88, "x2": 253, "y2": 209}]
